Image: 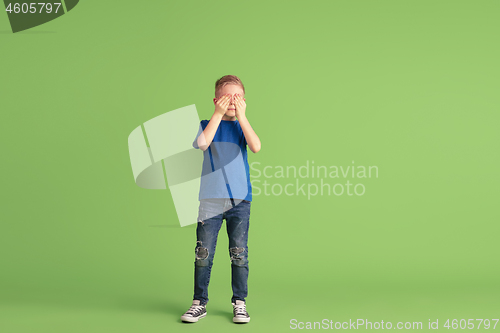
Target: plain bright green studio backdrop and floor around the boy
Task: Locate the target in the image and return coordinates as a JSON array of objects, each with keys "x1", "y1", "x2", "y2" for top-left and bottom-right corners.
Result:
[{"x1": 0, "y1": 0, "x2": 500, "y2": 333}]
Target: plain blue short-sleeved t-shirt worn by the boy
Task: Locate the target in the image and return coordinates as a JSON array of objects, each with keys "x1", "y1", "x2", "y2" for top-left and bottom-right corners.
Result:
[{"x1": 193, "y1": 120, "x2": 252, "y2": 201}]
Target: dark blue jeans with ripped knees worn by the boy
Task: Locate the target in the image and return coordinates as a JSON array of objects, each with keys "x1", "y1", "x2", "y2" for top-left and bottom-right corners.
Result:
[{"x1": 193, "y1": 199, "x2": 251, "y2": 304}]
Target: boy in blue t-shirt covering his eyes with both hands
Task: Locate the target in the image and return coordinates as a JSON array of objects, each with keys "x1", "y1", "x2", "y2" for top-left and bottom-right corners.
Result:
[{"x1": 181, "y1": 75, "x2": 260, "y2": 323}]
